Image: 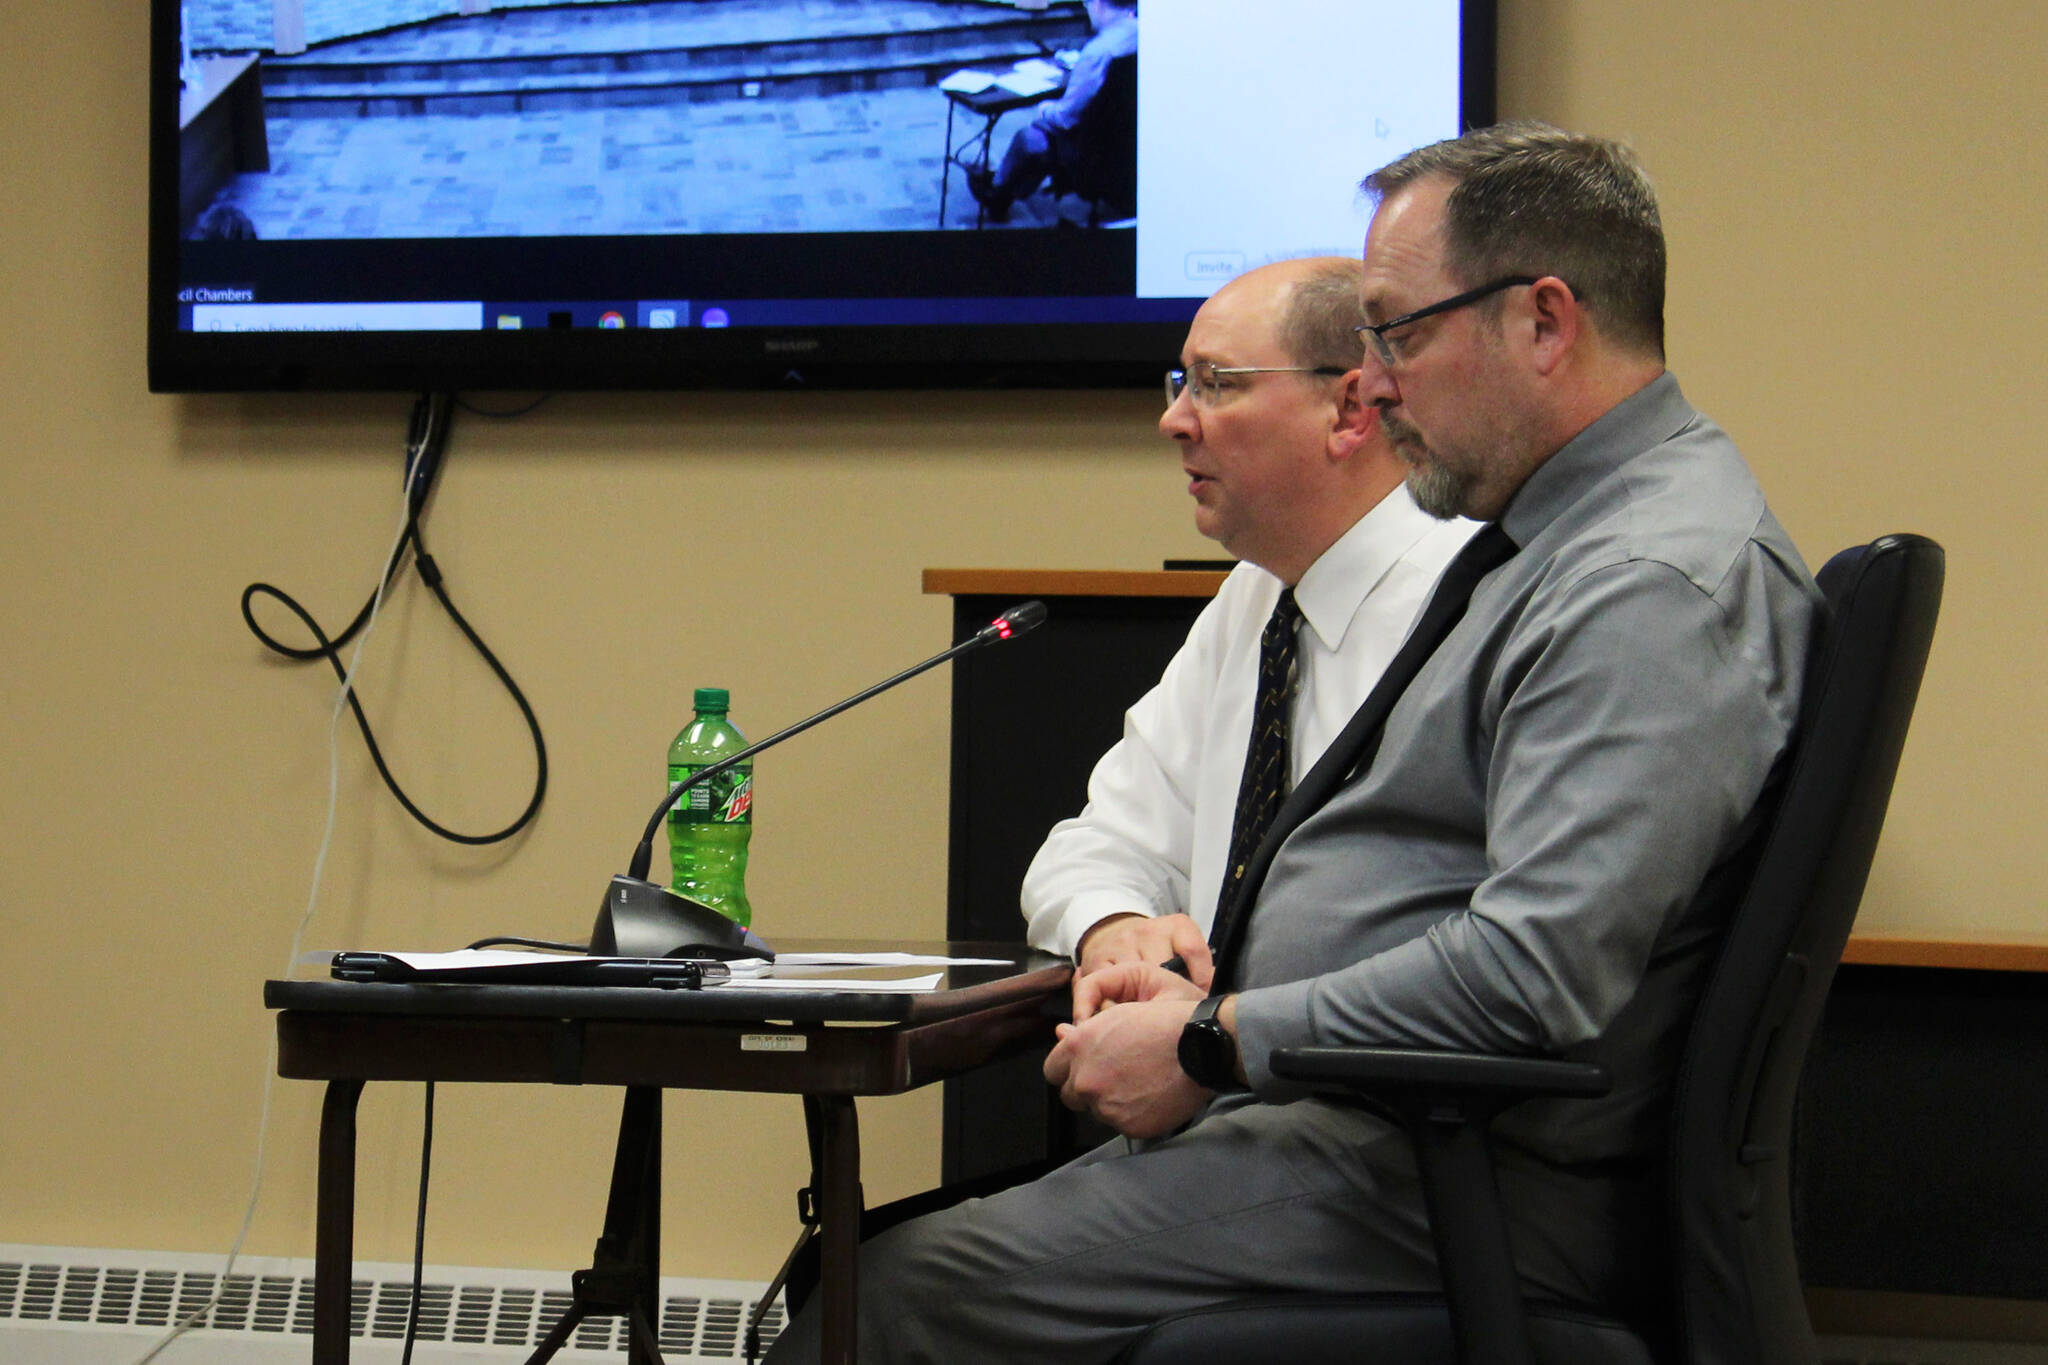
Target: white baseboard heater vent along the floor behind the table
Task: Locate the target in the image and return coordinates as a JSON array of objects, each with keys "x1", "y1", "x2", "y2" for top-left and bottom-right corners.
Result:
[{"x1": 0, "y1": 1242, "x2": 782, "y2": 1361}]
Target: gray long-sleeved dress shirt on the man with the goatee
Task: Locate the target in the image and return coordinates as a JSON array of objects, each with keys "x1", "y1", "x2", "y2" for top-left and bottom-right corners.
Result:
[{"x1": 1237, "y1": 375, "x2": 1821, "y2": 1173}]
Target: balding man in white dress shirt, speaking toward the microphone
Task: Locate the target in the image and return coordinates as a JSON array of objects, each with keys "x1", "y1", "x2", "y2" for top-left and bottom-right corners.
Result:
[{"x1": 1022, "y1": 256, "x2": 1475, "y2": 986}]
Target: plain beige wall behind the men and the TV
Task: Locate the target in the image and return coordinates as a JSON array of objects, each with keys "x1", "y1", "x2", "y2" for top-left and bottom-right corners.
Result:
[{"x1": 0, "y1": 0, "x2": 2048, "y2": 1277}]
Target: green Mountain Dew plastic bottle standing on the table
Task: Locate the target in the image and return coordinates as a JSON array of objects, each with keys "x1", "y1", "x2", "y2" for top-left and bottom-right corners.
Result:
[{"x1": 668, "y1": 688, "x2": 754, "y2": 925}]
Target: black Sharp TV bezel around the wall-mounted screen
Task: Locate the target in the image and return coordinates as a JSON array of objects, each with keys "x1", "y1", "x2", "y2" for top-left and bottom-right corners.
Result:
[{"x1": 145, "y1": 0, "x2": 1497, "y2": 393}]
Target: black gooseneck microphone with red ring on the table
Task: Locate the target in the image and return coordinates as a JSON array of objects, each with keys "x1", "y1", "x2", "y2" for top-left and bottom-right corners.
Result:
[{"x1": 590, "y1": 602, "x2": 1047, "y2": 960}]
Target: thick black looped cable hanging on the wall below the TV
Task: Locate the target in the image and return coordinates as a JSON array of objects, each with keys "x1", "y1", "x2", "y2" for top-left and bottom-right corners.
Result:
[{"x1": 242, "y1": 393, "x2": 547, "y2": 845}]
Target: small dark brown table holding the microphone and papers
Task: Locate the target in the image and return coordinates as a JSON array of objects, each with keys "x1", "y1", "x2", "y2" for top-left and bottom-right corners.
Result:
[{"x1": 264, "y1": 941, "x2": 1071, "y2": 1365}]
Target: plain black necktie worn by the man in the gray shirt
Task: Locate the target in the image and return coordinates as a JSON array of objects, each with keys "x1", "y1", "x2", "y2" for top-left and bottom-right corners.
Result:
[{"x1": 1208, "y1": 522, "x2": 1516, "y2": 990}]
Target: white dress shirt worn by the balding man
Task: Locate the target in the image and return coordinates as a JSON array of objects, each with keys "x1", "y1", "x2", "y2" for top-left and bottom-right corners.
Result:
[{"x1": 1022, "y1": 487, "x2": 1477, "y2": 956}]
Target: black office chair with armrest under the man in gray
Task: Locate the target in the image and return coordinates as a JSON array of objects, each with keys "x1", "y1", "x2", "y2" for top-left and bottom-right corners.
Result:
[{"x1": 1120, "y1": 536, "x2": 1944, "y2": 1365}]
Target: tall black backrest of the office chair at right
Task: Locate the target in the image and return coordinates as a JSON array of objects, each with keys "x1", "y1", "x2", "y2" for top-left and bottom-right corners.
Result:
[{"x1": 1669, "y1": 536, "x2": 1944, "y2": 1365}]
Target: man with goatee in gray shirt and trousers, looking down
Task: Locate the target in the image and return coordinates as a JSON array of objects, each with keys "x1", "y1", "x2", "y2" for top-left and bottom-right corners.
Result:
[{"x1": 774, "y1": 125, "x2": 1819, "y2": 1363}]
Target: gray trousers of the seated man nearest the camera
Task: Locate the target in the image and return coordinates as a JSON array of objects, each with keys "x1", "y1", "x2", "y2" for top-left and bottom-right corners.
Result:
[{"x1": 768, "y1": 1097, "x2": 1616, "y2": 1365}]
